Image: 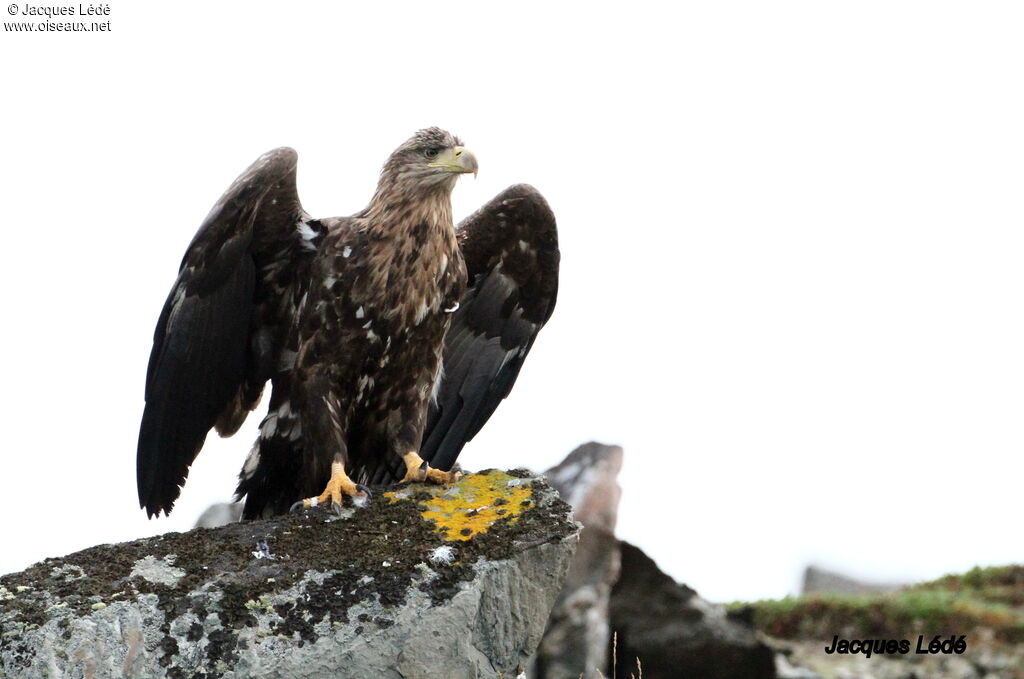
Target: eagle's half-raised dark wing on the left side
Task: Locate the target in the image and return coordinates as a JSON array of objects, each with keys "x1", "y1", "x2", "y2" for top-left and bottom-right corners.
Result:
[{"x1": 136, "y1": 148, "x2": 318, "y2": 516}]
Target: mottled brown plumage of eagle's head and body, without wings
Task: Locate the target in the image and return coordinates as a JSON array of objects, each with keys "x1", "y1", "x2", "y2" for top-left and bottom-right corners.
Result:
[{"x1": 292, "y1": 130, "x2": 475, "y2": 507}]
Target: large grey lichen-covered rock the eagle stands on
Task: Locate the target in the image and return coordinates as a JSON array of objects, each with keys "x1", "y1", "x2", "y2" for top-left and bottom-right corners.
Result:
[{"x1": 0, "y1": 471, "x2": 579, "y2": 679}]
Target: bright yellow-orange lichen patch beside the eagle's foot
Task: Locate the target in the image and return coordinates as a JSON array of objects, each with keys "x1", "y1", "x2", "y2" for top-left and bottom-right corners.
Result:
[{"x1": 384, "y1": 471, "x2": 534, "y2": 540}]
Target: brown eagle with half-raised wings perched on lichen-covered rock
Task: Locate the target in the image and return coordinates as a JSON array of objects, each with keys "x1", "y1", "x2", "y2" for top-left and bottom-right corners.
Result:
[{"x1": 136, "y1": 127, "x2": 559, "y2": 518}]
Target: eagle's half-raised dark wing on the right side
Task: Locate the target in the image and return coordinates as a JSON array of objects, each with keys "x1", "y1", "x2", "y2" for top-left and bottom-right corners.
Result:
[{"x1": 420, "y1": 184, "x2": 559, "y2": 469}]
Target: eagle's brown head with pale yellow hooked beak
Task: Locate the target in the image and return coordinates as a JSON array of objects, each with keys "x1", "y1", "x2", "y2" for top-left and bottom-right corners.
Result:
[{"x1": 377, "y1": 127, "x2": 477, "y2": 199}]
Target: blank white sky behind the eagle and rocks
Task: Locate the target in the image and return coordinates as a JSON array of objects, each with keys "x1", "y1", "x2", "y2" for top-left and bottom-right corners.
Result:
[{"x1": 0, "y1": 0, "x2": 1024, "y2": 599}]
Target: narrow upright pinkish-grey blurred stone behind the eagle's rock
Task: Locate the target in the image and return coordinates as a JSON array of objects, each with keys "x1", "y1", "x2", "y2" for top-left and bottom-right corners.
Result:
[{"x1": 527, "y1": 442, "x2": 623, "y2": 679}]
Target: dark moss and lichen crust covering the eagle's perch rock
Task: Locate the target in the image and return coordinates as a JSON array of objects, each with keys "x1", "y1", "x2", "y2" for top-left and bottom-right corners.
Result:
[{"x1": 0, "y1": 471, "x2": 577, "y2": 678}]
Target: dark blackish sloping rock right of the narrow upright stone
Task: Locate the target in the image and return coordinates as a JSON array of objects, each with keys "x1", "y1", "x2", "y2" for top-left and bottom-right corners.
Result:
[{"x1": 611, "y1": 542, "x2": 776, "y2": 679}]
